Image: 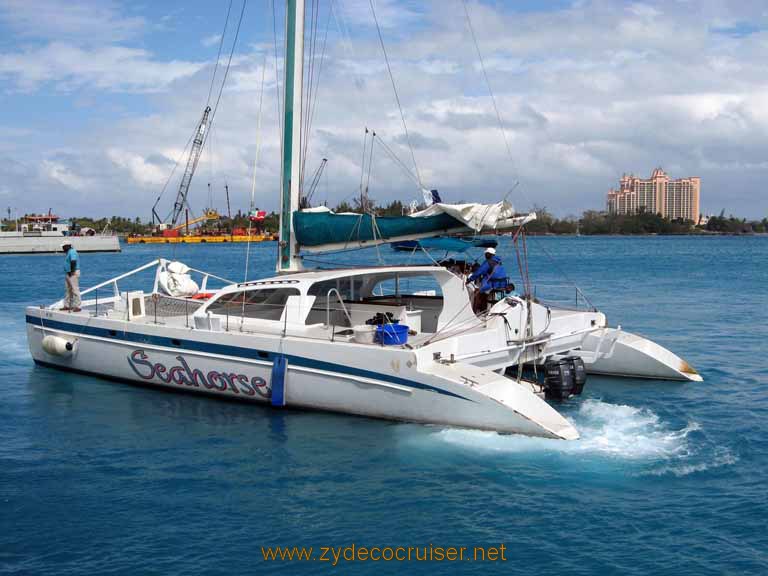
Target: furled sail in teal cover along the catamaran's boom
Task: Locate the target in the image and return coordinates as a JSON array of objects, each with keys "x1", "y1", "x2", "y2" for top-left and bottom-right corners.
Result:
[{"x1": 293, "y1": 202, "x2": 536, "y2": 252}]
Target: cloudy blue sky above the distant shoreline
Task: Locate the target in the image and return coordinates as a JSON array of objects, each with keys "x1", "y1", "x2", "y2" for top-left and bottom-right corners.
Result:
[{"x1": 0, "y1": 0, "x2": 768, "y2": 220}]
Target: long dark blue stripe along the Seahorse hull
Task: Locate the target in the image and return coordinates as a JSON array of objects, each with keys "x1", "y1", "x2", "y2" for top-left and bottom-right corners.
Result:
[{"x1": 27, "y1": 315, "x2": 472, "y2": 402}]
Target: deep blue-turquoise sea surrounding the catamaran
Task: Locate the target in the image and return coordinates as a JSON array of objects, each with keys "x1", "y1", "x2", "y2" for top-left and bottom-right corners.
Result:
[{"x1": 0, "y1": 237, "x2": 768, "y2": 576}]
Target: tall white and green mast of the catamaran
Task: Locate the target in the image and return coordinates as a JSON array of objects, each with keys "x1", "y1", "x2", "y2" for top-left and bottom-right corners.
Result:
[{"x1": 277, "y1": 0, "x2": 304, "y2": 272}]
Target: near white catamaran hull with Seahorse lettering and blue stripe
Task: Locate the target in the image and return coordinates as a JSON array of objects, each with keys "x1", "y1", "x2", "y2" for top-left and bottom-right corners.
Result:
[{"x1": 27, "y1": 308, "x2": 578, "y2": 439}]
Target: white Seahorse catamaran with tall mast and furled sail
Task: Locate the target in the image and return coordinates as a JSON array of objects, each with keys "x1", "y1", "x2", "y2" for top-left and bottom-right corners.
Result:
[{"x1": 26, "y1": 0, "x2": 701, "y2": 440}]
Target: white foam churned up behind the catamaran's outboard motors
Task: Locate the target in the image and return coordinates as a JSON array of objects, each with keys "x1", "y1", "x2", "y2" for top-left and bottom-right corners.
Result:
[{"x1": 434, "y1": 400, "x2": 699, "y2": 460}]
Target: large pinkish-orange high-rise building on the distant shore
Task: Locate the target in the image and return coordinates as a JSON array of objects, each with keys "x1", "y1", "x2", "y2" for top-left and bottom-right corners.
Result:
[{"x1": 608, "y1": 168, "x2": 701, "y2": 222}]
